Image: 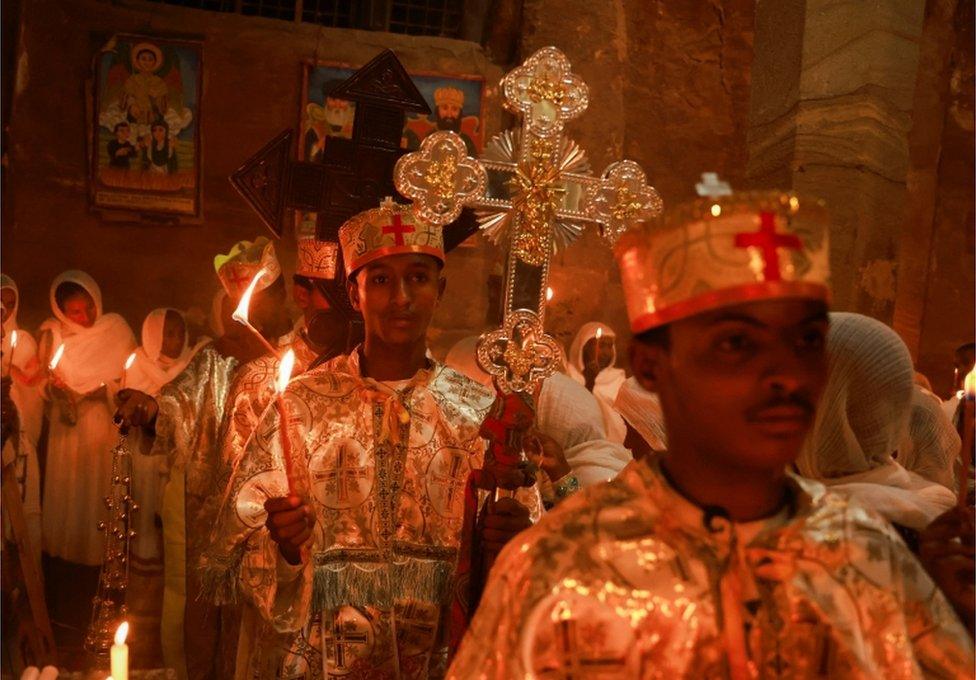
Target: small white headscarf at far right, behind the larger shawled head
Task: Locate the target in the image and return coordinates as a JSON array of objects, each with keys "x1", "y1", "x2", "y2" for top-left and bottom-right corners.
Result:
[{"x1": 897, "y1": 385, "x2": 961, "y2": 491}]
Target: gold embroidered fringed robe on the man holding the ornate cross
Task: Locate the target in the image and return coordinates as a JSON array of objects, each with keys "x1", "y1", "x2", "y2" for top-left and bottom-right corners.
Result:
[{"x1": 206, "y1": 352, "x2": 494, "y2": 678}]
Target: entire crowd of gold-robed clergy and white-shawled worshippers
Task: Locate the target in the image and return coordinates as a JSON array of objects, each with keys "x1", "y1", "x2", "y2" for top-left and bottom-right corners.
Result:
[{"x1": 2, "y1": 189, "x2": 976, "y2": 680}]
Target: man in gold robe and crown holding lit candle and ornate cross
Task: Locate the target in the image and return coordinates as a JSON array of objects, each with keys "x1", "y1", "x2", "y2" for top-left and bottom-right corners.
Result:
[{"x1": 206, "y1": 201, "x2": 529, "y2": 678}]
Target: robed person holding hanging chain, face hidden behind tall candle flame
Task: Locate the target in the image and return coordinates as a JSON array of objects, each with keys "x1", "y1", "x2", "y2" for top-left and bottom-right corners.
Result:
[{"x1": 116, "y1": 237, "x2": 291, "y2": 678}]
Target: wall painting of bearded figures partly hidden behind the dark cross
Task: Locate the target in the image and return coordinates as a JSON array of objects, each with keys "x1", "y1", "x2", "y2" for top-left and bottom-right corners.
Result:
[{"x1": 298, "y1": 62, "x2": 485, "y2": 162}]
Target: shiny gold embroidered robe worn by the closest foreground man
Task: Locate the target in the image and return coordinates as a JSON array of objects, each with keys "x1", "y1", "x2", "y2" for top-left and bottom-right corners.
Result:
[{"x1": 448, "y1": 458, "x2": 973, "y2": 680}]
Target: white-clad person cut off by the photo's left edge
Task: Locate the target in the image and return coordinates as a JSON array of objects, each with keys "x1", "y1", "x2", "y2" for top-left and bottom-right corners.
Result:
[{"x1": 0, "y1": 274, "x2": 44, "y2": 568}]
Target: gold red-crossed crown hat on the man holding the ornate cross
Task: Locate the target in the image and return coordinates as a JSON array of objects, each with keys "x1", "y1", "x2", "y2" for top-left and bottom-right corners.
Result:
[{"x1": 339, "y1": 198, "x2": 444, "y2": 276}]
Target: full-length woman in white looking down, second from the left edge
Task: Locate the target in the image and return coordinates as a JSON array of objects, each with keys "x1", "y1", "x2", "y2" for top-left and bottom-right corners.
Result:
[{"x1": 41, "y1": 270, "x2": 136, "y2": 565}]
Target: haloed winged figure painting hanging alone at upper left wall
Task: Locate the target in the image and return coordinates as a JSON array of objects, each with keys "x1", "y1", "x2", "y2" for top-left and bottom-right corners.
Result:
[{"x1": 90, "y1": 35, "x2": 203, "y2": 217}]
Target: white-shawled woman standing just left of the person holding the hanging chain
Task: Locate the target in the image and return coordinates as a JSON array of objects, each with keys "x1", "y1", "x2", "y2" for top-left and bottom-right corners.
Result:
[{"x1": 125, "y1": 307, "x2": 210, "y2": 571}]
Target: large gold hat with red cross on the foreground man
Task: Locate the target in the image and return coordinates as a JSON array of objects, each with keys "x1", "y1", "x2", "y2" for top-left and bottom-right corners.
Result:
[{"x1": 615, "y1": 186, "x2": 830, "y2": 334}]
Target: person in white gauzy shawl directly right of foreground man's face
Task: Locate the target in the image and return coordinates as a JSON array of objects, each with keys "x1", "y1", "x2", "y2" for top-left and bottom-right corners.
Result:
[{"x1": 796, "y1": 313, "x2": 955, "y2": 530}]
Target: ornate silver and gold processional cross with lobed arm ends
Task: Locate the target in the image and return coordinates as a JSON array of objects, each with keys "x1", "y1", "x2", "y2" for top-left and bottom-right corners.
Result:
[{"x1": 394, "y1": 47, "x2": 662, "y2": 392}]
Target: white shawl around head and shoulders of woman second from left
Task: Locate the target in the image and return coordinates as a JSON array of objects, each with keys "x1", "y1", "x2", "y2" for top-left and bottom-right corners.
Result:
[{"x1": 41, "y1": 270, "x2": 136, "y2": 394}]
